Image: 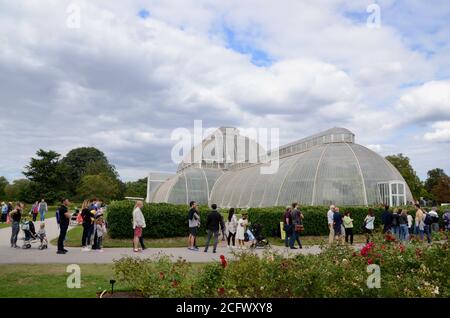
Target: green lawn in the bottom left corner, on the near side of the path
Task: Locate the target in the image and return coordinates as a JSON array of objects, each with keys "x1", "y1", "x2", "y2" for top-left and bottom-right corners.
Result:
[{"x1": 0, "y1": 264, "x2": 120, "y2": 298}]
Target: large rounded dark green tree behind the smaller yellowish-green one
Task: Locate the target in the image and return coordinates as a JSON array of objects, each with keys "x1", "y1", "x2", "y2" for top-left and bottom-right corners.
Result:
[{"x1": 62, "y1": 147, "x2": 118, "y2": 193}]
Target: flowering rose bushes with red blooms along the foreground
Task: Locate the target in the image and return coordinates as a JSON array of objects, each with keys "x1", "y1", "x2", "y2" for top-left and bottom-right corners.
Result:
[{"x1": 115, "y1": 241, "x2": 450, "y2": 298}]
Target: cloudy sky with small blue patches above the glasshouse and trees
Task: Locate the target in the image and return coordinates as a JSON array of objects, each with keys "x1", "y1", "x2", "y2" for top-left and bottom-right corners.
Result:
[{"x1": 0, "y1": 0, "x2": 450, "y2": 181}]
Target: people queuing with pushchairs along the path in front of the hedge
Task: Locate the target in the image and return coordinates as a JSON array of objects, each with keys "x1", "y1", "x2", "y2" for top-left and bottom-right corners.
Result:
[{"x1": 1, "y1": 199, "x2": 450, "y2": 254}]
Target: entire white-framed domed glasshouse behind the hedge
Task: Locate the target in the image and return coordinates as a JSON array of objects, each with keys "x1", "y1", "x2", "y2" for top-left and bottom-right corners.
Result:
[{"x1": 147, "y1": 127, "x2": 412, "y2": 208}]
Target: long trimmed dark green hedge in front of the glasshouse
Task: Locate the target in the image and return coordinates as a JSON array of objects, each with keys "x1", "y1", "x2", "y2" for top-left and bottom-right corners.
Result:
[{"x1": 107, "y1": 201, "x2": 444, "y2": 238}]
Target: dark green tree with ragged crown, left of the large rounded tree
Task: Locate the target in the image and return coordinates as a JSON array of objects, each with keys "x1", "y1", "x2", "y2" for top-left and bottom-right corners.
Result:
[{"x1": 23, "y1": 149, "x2": 68, "y2": 202}]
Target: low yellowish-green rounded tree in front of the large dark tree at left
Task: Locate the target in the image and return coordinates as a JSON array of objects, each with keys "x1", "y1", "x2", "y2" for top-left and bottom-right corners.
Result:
[{"x1": 77, "y1": 174, "x2": 120, "y2": 201}]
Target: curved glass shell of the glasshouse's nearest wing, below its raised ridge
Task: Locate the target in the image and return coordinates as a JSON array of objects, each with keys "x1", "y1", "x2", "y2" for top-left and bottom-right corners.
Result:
[{"x1": 210, "y1": 142, "x2": 412, "y2": 207}]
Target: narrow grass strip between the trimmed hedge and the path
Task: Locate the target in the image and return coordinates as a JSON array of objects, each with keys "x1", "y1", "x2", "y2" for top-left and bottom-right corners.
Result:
[{"x1": 51, "y1": 225, "x2": 366, "y2": 248}]
